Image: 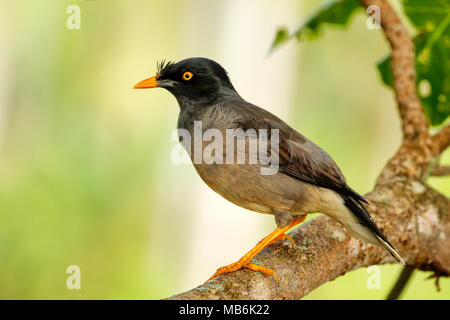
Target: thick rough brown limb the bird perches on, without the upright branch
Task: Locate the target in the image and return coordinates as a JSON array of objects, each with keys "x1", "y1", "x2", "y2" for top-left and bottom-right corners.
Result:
[{"x1": 170, "y1": 181, "x2": 450, "y2": 299}]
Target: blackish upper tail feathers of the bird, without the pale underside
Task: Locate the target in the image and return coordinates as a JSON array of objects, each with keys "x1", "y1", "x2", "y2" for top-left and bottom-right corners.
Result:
[{"x1": 341, "y1": 189, "x2": 405, "y2": 265}]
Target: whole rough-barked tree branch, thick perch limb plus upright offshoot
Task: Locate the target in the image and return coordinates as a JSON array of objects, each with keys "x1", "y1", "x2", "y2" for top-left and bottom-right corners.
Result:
[{"x1": 166, "y1": 0, "x2": 450, "y2": 299}]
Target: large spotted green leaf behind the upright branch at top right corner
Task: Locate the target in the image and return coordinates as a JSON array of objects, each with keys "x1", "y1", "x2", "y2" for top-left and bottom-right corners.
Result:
[{"x1": 378, "y1": 0, "x2": 450, "y2": 125}]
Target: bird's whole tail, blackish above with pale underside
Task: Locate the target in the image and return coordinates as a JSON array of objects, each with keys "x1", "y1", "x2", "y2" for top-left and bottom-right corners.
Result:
[{"x1": 341, "y1": 190, "x2": 405, "y2": 265}]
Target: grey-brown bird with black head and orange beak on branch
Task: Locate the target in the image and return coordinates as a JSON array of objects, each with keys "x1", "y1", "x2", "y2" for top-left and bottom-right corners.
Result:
[{"x1": 134, "y1": 57, "x2": 405, "y2": 282}]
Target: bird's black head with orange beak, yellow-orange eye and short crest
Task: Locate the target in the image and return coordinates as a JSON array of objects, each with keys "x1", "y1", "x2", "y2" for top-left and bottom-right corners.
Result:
[{"x1": 134, "y1": 58, "x2": 239, "y2": 107}]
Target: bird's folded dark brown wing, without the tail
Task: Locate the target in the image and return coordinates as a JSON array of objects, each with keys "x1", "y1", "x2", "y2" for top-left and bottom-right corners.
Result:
[{"x1": 223, "y1": 102, "x2": 366, "y2": 202}]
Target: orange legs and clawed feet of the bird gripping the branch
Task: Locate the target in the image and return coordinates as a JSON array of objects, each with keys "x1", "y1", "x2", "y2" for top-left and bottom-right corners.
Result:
[{"x1": 208, "y1": 215, "x2": 306, "y2": 283}]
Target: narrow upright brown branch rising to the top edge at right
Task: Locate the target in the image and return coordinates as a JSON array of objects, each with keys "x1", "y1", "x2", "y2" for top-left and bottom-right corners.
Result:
[{"x1": 366, "y1": 0, "x2": 431, "y2": 180}]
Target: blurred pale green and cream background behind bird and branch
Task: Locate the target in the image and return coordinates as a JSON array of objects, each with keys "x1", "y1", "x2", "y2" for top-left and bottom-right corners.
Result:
[{"x1": 0, "y1": 0, "x2": 450, "y2": 299}]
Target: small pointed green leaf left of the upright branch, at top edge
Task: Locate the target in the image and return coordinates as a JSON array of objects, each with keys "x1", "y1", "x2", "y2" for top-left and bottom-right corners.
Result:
[{"x1": 270, "y1": 0, "x2": 362, "y2": 51}]
